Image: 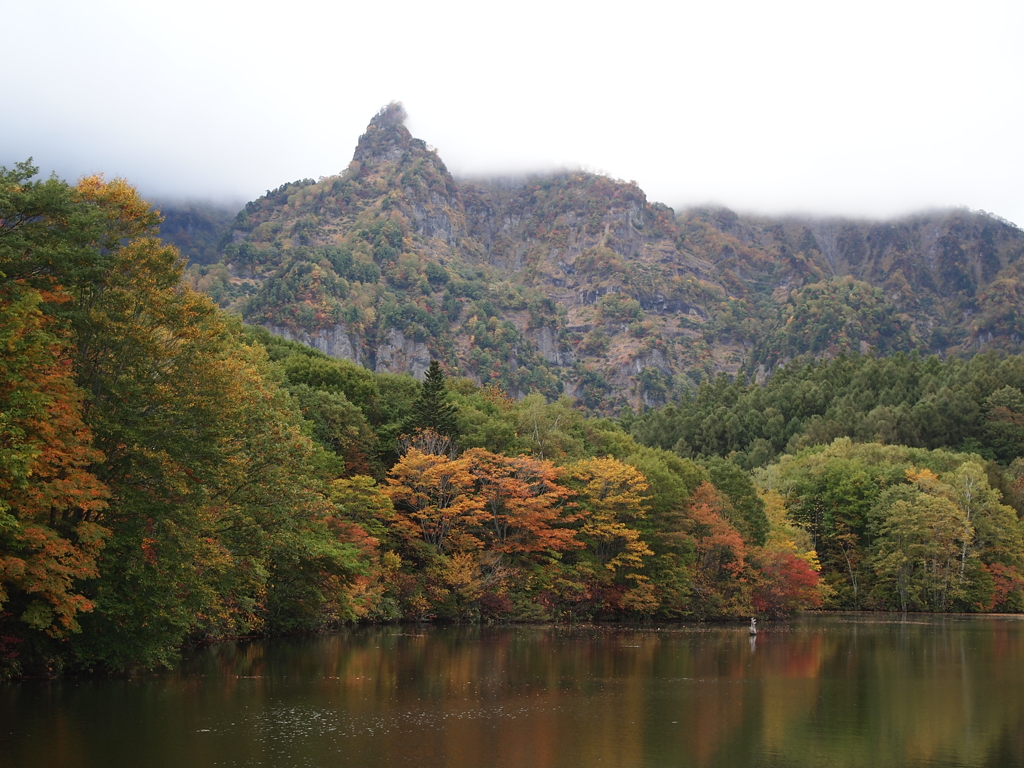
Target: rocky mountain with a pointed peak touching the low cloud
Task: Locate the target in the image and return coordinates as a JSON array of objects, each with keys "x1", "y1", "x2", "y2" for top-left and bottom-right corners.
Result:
[{"x1": 184, "y1": 103, "x2": 1024, "y2": 413}]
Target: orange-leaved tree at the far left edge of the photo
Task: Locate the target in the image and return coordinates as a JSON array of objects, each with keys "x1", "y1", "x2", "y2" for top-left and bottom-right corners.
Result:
[{"x1": 0, "y1": 281, "x2": 109, "y2": 647}]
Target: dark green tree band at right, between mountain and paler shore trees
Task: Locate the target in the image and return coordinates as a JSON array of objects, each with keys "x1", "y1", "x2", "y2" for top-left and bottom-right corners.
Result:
[{"x1": 632, "y1": 354, "x2": 1024, "y2": 468}]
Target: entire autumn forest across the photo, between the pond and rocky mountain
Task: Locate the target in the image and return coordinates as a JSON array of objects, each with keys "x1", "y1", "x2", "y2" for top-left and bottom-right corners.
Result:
[{"x1": 6, "y1": 163, "x2": 1024, "y2": 676}]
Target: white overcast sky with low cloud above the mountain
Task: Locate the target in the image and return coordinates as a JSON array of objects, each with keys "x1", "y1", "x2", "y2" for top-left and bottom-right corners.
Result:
[{"x1": 8, "y1": 0, "x2": 1024, "y2": 226}]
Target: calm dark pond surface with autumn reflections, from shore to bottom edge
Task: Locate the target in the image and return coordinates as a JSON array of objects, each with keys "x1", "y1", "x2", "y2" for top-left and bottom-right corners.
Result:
[{"x1": 0, "y1": 615, "x2": 1024, "y2": 768}]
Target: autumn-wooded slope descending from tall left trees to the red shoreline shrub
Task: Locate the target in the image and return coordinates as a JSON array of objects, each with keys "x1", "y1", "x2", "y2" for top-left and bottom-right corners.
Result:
[{"x1": 0, "y1": 164, "x2": 819, "y2": 675}]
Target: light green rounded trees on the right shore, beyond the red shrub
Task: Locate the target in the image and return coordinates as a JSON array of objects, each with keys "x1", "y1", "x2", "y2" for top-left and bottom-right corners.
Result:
[{"x1": 759, "y1": 438, "x2": 1024, "y2": 610}]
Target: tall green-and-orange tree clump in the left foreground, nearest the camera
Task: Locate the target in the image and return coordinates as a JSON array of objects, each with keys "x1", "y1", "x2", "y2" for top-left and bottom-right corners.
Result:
[{"x1": 0, "y1": 165, "x2": 358, "y2": 669}]
